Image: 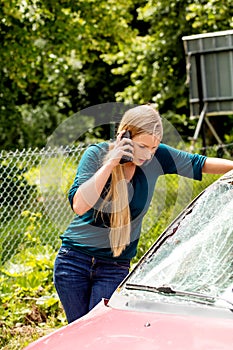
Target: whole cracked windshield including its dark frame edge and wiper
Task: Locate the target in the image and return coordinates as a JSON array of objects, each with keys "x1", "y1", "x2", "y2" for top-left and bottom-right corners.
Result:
[{"x1": 110, "y1": 172, "x2": 233, "y2": 309}]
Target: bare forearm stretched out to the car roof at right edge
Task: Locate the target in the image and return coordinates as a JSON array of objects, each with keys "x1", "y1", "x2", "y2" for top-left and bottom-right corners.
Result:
[{"x1": 202, "y1": 157, "x2": 233, "y2": 174}]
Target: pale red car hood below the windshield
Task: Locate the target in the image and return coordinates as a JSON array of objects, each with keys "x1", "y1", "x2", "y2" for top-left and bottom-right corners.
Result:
[{"x1": 26, "y1": 302, "x2": 233, "y2": 350}]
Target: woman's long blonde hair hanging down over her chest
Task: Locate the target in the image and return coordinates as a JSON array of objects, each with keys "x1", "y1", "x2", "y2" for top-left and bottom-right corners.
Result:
[{"x1": 103, "y1": 105, "x2": 163, "y2": 257}]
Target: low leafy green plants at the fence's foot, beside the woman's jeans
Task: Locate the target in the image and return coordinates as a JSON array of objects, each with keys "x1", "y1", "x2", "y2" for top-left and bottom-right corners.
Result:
[{"x1": 0, "y1": 211, "x2": 65, "y2": 349}]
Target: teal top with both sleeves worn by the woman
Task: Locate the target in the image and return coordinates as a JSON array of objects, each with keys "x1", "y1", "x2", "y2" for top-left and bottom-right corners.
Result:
[{"x1": 61, "y1": 142, "x2": 206, "y2": 261}]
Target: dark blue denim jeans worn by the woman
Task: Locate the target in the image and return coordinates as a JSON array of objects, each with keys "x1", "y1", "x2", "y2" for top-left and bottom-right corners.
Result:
[{"x1": 54, "y1": 247, "x2": 130, "y2": 323}]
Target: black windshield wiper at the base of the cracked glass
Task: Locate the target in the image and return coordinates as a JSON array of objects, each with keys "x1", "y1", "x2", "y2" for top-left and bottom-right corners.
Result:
[{"x1": 125, "y1": 283, "x2": 233, "y2": 311}]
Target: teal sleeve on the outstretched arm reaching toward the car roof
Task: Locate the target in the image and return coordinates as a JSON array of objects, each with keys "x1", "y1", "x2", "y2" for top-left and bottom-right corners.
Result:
[{"x1": 155, "y1": 144, "x2": 207, "y2": 180}]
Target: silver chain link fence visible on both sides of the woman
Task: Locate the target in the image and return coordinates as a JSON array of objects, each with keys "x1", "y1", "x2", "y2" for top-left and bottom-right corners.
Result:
[{"x1": 0, "y1": 144, "x2": 231, "y2": 263}]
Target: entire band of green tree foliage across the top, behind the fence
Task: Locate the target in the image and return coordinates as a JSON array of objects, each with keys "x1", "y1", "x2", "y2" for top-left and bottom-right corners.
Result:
[{"x1": 0, "y1": 0, "x2": 233, "y2": 149}]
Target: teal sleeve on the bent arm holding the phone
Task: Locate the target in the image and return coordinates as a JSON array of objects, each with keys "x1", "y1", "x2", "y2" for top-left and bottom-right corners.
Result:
[{"x1": 68, "y1": 143, "x2": 108, "y2": 209}]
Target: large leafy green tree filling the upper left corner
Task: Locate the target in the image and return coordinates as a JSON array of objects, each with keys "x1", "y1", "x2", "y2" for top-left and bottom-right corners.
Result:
[{"x1": 0, "y1": 0, "x2": 136, "y2": 149}]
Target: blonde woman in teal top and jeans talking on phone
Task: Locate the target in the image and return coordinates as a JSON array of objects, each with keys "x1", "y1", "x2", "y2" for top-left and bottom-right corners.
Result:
[{"x1": 54, "y1": 105, "x2": 233, "y2": 323}]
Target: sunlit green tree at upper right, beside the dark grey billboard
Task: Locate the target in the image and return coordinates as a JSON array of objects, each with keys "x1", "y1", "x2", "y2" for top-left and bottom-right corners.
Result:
[{"x1": 105, "y1": 0, "x2": 233, "y2": 136}]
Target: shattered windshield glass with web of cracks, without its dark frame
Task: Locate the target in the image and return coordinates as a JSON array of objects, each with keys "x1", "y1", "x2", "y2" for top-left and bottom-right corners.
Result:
[{"x1": 122, "y1": 181, "x2": 233, "y2": 308}]
